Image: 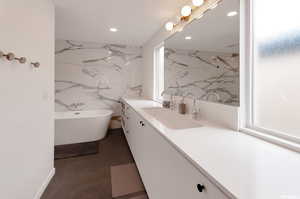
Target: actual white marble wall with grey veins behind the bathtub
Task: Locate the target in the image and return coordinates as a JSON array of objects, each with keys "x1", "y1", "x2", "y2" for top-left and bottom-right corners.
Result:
[{"x1": 55, "y1": 40, "x2": 142, "y2": 115}]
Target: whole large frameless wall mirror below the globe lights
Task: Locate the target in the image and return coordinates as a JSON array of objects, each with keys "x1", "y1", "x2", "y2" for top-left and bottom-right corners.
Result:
[{"x1": 164, "y1": 0, "x2": 239, "y2": 106}]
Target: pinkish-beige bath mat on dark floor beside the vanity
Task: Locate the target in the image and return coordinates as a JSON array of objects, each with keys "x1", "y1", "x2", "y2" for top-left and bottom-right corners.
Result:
[{"x1": 110, "y1": 164, "x2": 145, "y2": 198}]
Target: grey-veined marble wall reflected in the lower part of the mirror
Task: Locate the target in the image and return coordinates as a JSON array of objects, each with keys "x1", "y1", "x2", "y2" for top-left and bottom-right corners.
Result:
[{"x1": 165, "y1": 47, "x2": 239, "y2": 106}]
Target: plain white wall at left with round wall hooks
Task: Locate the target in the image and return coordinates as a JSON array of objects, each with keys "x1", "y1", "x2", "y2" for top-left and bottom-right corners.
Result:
[{"x1": 0, "y1": 0, "x2": 54, "y2": 199}]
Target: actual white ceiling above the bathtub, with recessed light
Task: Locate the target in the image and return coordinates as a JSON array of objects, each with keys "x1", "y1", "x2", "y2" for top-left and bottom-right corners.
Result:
[{"x1": 54, "y1": 0, "x2": 189, "y2": 46}]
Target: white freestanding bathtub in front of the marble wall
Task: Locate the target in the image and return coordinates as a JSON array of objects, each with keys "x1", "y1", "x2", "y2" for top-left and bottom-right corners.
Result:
[{"x1": 55, "y1": 109, "x2": 113, "y2": 145}]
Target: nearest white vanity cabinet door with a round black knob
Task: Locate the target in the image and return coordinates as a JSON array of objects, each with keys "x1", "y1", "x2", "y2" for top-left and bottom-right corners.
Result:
[{"x1": 138, "y1": 119, "x2": 228, "y2": 199}]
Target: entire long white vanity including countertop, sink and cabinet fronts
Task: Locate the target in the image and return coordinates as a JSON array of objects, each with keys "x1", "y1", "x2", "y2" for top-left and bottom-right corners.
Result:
[{"x1": 122, "y1": 99, "x2": 300, "y2": 199}]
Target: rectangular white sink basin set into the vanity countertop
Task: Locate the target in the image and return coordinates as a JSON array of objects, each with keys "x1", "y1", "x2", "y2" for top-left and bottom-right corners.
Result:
[{"x1": 142, "y1": 107, "x2": 202, "y2": 129}]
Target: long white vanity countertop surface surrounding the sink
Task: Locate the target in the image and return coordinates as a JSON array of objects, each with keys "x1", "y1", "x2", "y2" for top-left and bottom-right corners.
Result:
[{"x1": 124, "y1": 99, "x2": 300, "y2": 199}]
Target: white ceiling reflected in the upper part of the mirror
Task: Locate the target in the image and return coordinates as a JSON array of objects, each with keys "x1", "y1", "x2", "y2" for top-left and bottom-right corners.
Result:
[{"x1": 165, "y1": 0, "x2": 239, "y2": 53}]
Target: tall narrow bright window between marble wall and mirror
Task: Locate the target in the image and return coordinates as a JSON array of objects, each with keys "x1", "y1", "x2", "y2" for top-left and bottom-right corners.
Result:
[{"x1": 153, "y1": 43, "x2": 165, "y2": 102}]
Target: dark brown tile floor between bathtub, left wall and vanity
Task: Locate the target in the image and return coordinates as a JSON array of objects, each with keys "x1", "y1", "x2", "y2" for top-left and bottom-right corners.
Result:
[{"x1": 41, "y1": 130, "x2": 139, "y2": 199}]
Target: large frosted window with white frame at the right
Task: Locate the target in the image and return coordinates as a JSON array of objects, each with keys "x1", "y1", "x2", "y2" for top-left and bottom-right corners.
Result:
[{"x1": 242, "y1": 0, "x2": 300, "y2": 149}]
